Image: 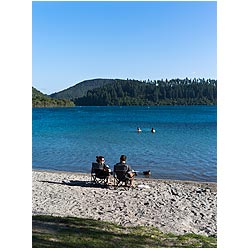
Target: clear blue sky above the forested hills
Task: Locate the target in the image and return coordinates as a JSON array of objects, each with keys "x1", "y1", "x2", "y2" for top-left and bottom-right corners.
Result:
[{"x1": 32, "y1": 1, "x2": 217, "y2": 94}]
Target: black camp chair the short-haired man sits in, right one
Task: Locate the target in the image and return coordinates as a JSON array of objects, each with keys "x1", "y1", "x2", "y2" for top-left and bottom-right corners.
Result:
[{"x1": 113, "y1": 164, "x2": 134, "y2": 188}]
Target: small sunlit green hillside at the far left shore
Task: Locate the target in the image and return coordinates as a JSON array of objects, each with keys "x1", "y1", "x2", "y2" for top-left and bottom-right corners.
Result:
[{"x1": 32, "y1": 87, "x2": 74, "y2": 108}]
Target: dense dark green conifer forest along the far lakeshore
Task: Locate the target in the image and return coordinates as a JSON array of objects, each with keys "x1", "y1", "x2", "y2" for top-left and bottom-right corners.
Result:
[{"x1": 72, "y1": 78, "x2": 217, "y2": 106}]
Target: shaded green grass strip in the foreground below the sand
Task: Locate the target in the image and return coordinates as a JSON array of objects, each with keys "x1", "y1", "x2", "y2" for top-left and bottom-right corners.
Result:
[{"x1": 32, "y1": 215, "x2": 217, "y2": 248}]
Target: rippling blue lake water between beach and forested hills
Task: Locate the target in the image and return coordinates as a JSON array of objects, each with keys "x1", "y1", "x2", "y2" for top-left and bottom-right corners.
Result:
[{"x1": 32, "y1": 106, "x2": 217, "y2": 182}]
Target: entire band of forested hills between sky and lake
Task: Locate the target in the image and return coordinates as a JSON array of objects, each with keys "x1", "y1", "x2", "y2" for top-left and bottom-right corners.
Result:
[{"x1": 33, "y1": 78, "x2": 217, "y2": 107}]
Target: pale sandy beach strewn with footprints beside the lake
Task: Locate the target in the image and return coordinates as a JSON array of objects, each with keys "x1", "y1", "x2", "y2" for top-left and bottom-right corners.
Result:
[{"x1": 32, "y1": 170, "x2": 217, "y2": 236}]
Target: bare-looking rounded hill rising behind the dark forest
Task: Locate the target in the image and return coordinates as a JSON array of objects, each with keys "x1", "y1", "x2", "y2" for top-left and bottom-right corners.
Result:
[{"x1": 50, "y1": 79, "x2": 115, "y2": 100}]
